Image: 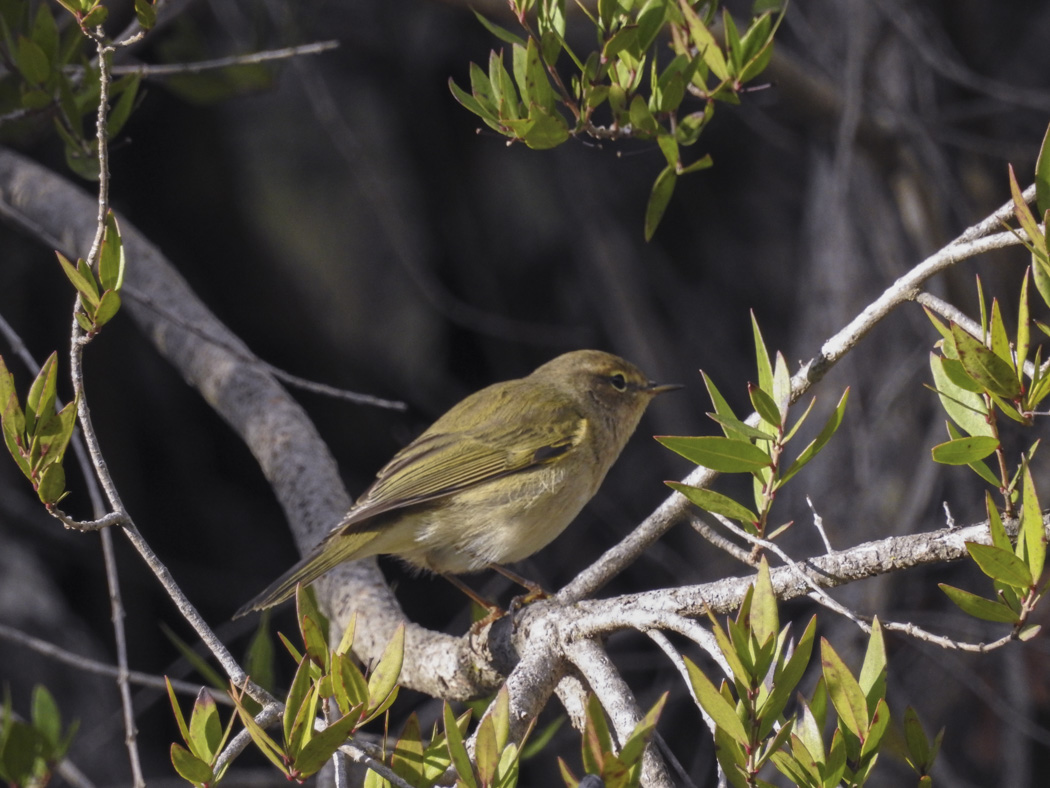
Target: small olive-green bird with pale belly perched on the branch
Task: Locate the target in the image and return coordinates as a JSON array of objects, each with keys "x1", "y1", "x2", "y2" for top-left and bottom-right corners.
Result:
[{"x1": 236, "y1": 350, "x2": 681, "y2": 616}]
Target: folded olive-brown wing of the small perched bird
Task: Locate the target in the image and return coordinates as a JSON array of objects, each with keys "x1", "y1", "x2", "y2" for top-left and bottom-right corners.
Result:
[{"x1": 339, "y1": 396, "x2": 587, "y2": 533}]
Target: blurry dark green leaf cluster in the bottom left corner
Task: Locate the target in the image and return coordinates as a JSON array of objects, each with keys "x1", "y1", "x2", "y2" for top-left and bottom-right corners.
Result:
[{"x1": 0, "y1": 684, "x2": 78, "y2": 788}]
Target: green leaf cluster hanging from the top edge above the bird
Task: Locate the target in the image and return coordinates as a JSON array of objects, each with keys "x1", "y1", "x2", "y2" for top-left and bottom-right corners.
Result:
[{"x1": 448, "y1": 0, "x2": 782, "y2": 240}]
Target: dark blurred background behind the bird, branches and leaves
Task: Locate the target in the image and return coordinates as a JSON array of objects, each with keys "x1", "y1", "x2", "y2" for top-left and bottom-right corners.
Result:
[{"x1": 0, "y1": 0, "x2": 1050, "y2": 788}]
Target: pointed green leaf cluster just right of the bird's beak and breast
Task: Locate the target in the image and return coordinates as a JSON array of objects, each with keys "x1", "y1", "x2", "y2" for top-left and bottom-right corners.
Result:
[{"x1": 656, "y1": 315, "x2": 849, "y2": 539}]
